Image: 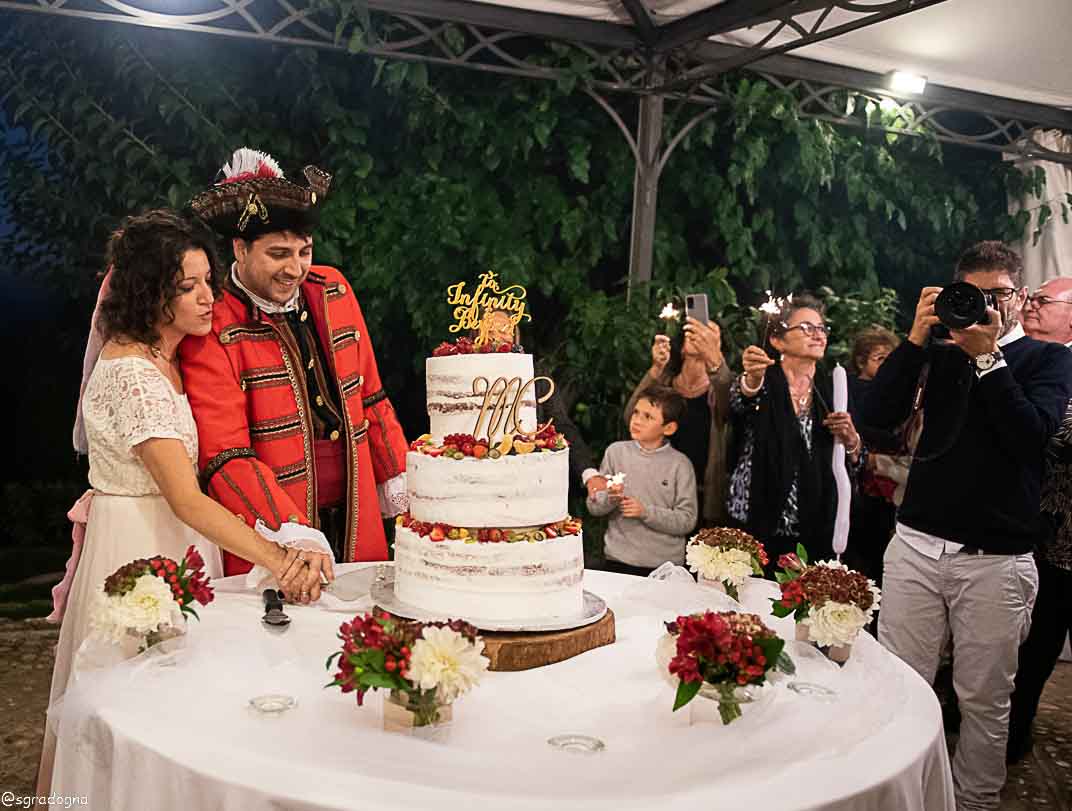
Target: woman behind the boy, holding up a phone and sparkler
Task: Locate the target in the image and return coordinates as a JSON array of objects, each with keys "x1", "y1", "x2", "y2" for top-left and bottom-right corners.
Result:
[{"x1": 613, "y1": 318, "x2": 733, "y2": 526}]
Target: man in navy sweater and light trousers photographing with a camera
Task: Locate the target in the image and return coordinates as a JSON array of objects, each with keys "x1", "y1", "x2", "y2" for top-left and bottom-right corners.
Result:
[{"x1": 860, "y1": 242, "x2": 1072, "y2": 811}]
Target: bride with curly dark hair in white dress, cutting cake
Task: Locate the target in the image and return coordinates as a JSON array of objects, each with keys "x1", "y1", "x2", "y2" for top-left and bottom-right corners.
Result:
[{"x1": 39, "y1": 209, "x2": 334, "y2": 795}]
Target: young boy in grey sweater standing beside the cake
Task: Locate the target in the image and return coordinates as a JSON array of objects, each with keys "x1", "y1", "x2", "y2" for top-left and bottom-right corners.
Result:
[{"x1": 587, "y1": 386, "x2": 697, "y2": 576}]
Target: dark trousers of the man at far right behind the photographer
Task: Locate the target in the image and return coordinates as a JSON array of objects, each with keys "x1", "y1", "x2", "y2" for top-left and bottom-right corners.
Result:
[{"x1": 1009, "y1": 555, "x2": 1072, "y2": 749}]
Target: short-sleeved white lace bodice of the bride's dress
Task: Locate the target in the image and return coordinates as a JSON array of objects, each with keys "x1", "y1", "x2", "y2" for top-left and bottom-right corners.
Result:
[{"x1": 81, "y1": 357, "x2": 197, "y2": 496}]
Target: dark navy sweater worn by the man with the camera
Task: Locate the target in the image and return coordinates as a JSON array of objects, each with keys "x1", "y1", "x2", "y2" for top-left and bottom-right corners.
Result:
[{"x1": 858, "y1": 337, "x2": 1072, "y2": 555}]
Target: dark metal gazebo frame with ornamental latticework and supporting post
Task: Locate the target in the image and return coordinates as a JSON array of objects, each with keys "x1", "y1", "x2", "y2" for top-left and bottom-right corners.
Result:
[{"x1": 0, "y1": 0, "x2": 1072, "y2": 285}]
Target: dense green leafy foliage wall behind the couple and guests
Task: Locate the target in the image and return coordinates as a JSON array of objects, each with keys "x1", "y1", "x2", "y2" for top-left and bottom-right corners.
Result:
[{"x1": 0, "y1": 20, "x2": 1050, "y2": 479}]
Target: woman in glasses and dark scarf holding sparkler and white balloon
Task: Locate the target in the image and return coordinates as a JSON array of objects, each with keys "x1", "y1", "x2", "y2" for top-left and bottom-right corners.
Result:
[{"x1": 728, "y1": 296, "x2": 863, "y2": 567}]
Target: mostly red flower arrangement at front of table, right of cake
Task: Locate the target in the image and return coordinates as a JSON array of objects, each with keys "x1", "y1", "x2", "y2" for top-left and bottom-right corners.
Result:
[{"x1": 666, "y1": 611, "x2": 795, "y2": 724}]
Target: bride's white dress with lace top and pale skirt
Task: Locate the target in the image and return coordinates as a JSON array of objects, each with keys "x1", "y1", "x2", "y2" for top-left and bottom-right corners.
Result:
[{"x1": 49, "y1": 357, "x2": 223, "y2": 705}]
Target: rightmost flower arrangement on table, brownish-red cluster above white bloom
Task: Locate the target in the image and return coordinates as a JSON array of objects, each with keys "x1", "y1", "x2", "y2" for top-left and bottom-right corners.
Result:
[{"x1": 771, "y1": 544, "x2": 881, "y2": 657}]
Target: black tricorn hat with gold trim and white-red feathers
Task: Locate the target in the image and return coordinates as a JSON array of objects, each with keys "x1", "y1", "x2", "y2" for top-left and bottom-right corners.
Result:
[{"x1": 190, "y1": 147, "x2": 331, "y2": 240}]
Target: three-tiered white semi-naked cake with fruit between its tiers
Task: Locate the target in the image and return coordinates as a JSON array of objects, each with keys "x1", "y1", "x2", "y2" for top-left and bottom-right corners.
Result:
[{"x1": 394, "y1": 352, "x2": 584, "y2": 620}]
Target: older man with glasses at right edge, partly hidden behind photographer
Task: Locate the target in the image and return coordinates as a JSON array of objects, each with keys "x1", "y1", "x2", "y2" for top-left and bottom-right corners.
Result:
[{"x1": 1007, "y1": 279, "x2": 1072, "y2": 763}]
